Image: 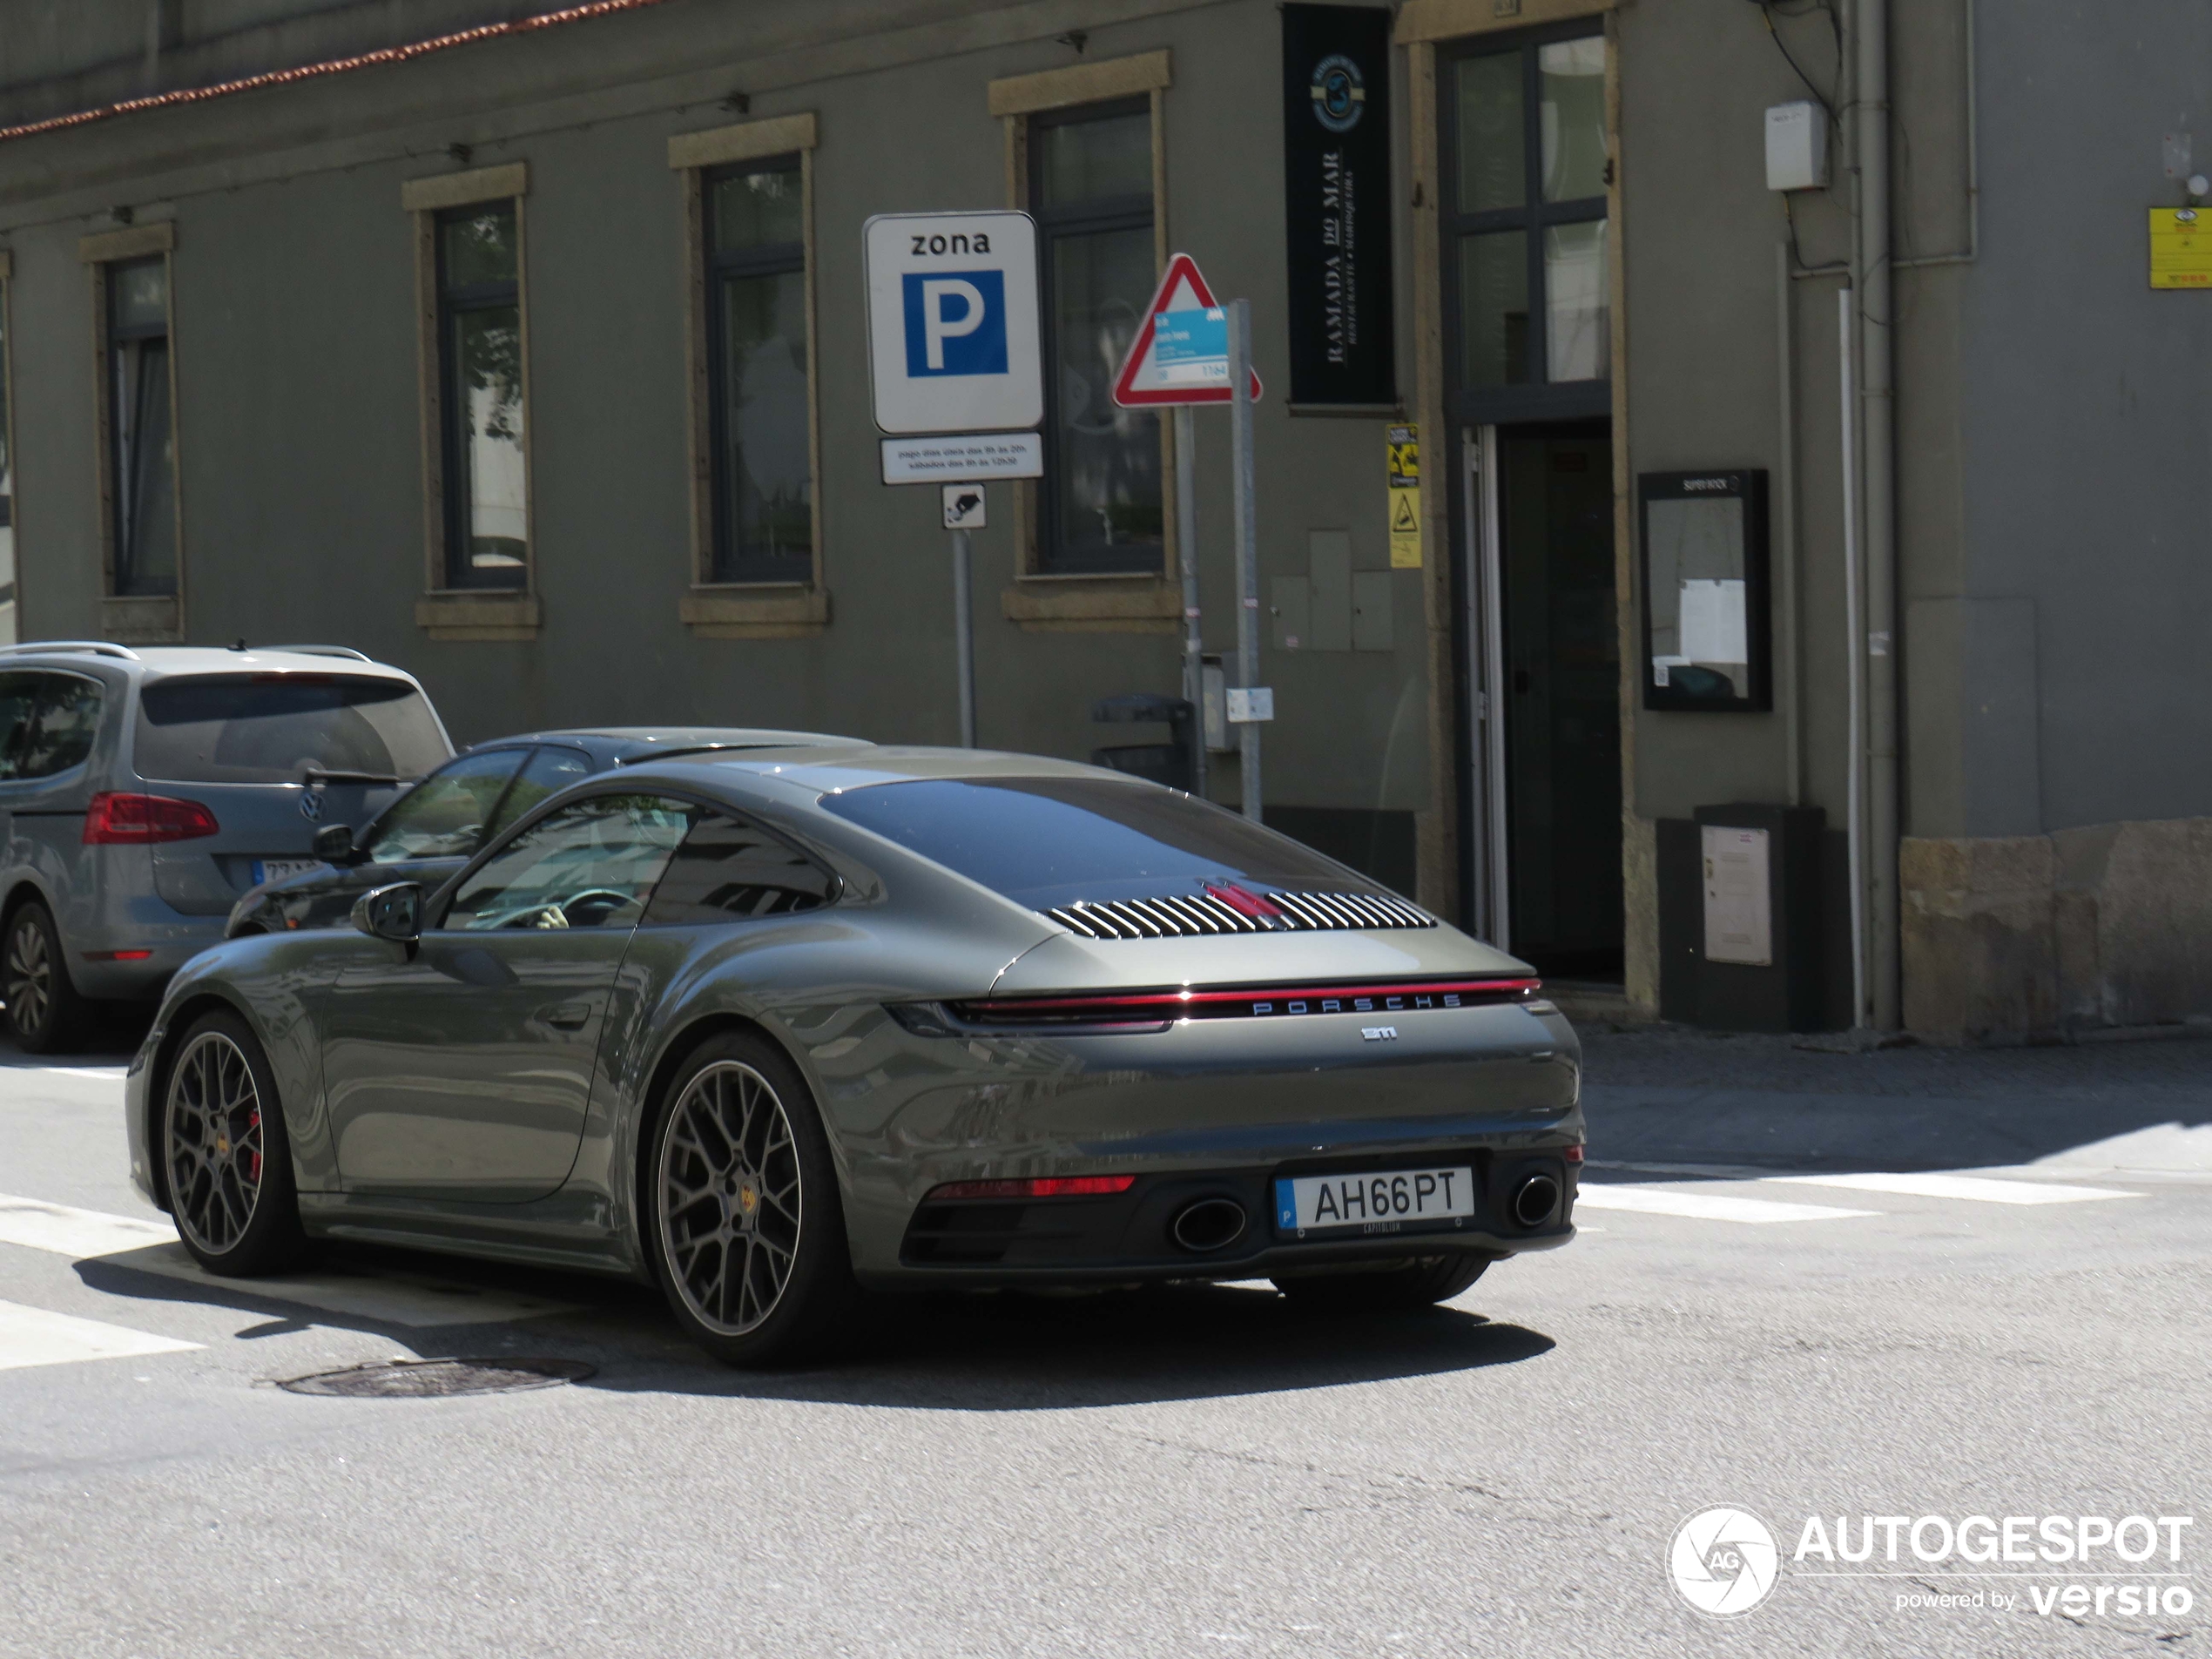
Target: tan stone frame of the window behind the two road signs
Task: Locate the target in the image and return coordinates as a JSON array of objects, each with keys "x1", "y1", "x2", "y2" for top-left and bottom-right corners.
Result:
[{"x1": 987, "y1": 49, "x2": 1184, "y2": 635}]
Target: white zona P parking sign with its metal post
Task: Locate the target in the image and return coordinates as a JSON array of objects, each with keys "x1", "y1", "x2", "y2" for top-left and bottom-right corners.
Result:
[{"x1": 860, "y1": 212, "x2": 1044, "y2": 748}]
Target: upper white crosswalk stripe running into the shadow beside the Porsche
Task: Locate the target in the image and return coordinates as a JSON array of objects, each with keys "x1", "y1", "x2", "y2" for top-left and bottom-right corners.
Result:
[{"x1": 0, "y1": 1192, "x2": 575, "y2": 1325}]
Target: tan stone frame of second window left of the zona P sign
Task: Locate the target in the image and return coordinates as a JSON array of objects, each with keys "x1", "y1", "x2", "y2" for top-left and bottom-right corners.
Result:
[{"x1": 401, "y1": 161, "x2": 544, "y2": 642}]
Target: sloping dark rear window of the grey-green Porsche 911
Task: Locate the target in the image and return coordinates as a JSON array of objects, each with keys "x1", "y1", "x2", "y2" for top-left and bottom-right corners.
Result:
[{"x1": 823, "y1": 777, "x2": 1353, "y2": 909}]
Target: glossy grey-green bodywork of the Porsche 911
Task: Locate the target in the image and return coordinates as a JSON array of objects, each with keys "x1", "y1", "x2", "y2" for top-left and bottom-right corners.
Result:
[{"x1": 126, "y1": 745, "x2": 1584, "y2": 1285}]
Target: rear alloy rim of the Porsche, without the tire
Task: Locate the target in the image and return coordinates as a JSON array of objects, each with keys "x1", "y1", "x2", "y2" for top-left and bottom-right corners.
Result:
[{"x1": 659, "y1": 1060, "x2": 800, "y2": 1336}]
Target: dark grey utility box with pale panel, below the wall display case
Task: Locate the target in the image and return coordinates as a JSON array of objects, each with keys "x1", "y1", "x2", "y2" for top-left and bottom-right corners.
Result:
[{"x1": 1659, "y1": 803, "x2": 1830, "y2": 1031}]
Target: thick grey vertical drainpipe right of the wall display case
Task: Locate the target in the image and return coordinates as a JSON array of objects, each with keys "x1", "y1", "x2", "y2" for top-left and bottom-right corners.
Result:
[{"x1": 1851, "y1": 0, "x2": 1902, "y2": 1031}]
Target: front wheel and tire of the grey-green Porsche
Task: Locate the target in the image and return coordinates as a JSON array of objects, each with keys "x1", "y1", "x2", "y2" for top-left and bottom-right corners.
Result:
[{"x1": 159, "y1": 1008, "x2": 306, "y2": 1278}]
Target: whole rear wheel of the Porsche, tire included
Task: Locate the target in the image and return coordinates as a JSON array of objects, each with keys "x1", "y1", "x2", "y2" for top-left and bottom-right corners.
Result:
[{"x1": 639, "y1": 1031, "x2": 860, "y2": 1369}]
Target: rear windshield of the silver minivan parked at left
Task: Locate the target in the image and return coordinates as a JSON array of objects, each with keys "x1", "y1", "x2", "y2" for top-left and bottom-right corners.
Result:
[{"x1": 137, "y1": 675, "x2": 451, "y2": 783}]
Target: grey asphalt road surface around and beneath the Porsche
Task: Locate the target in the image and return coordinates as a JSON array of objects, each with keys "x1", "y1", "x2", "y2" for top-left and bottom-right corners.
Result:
[{"x1": 0, "y1": 1035, "x2": 2212, "y2": 1659}]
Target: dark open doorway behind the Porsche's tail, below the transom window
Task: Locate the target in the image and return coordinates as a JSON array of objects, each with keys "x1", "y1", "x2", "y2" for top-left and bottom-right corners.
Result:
[{"x1": 1460, "y1": 421, "x2": 1622, "y2": 980}]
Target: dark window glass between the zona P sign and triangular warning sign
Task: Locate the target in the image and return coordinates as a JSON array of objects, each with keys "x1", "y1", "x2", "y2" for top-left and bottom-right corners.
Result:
[{"x1": 1028, "y1": 99, "x2": 1166, "y2": 575}]
